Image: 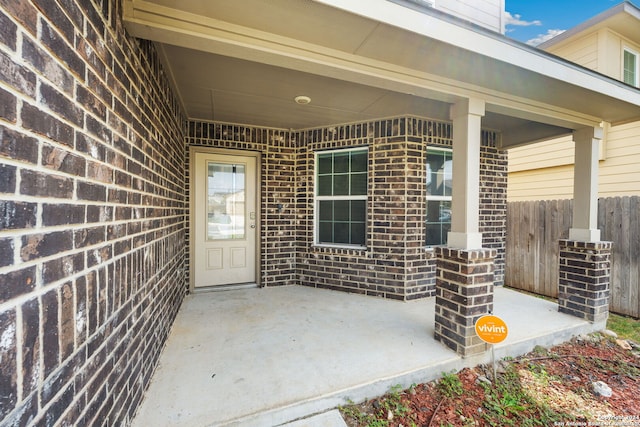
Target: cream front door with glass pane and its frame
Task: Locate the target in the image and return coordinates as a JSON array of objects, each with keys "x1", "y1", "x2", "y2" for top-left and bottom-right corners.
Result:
[{"x1": 191, "y1": 150, "x2": 258, "y2": 288}]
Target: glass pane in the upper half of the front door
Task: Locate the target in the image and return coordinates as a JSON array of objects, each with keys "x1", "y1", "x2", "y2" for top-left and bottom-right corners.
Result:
[{"x1": 206, "y1": 162, "x2": 246, "y2": 240}]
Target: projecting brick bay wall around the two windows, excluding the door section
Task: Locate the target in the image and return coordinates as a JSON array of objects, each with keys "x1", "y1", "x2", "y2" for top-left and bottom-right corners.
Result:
[{"x1": 297, "y1": 117, "x2": 506, "y2": 300}]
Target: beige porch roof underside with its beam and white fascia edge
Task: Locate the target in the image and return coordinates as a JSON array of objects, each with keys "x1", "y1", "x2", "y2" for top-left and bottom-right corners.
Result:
[{"x1": 125, "y1": 0, "x2": 640, "y2": 149}]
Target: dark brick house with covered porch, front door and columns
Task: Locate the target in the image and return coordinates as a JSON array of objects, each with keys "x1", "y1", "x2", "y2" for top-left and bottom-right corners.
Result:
[{"x1": 0, "y1": 0, "x2": 640, "y2": 425}]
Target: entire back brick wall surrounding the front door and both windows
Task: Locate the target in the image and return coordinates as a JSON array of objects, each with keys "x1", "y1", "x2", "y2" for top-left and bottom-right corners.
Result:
[{"x1": 186, "y1": 117, "x2": 506, "y2": 300}]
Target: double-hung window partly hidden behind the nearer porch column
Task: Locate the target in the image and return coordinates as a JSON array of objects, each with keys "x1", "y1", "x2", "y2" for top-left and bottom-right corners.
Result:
[{"x1": 425, "y1": 148, "x2": 453, "y2": 246}]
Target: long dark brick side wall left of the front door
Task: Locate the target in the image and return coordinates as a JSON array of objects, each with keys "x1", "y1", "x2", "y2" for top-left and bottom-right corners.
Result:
[{"x1": 0, "y1": 0, "x2": 185, "y2": 426}]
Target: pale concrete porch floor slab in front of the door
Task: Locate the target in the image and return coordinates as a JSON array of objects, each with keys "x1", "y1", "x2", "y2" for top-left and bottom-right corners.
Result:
[{"x1": 133, "y1": 286, "x2": 604, "y2": 427}]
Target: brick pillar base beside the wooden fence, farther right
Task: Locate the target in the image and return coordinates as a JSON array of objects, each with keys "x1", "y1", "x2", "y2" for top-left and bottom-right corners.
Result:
[{"x1": 558, "y1": 240, "x2": 612, "y2": 323}]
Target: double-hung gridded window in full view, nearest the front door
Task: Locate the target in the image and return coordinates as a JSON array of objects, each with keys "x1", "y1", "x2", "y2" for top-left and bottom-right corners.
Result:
[{"x1": 315, "y1": 148, "x2": 369, "y2": 247}]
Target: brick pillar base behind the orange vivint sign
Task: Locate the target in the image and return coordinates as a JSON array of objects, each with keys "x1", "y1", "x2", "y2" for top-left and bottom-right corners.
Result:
[{"x1": 435, "y1": 247, "x2": 497, "y2": 357}]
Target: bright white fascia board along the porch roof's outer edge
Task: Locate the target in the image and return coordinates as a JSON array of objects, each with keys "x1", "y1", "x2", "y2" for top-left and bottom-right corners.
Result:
[{"x1": 314, "y1": 0, "x2": 640, "y2": 105}]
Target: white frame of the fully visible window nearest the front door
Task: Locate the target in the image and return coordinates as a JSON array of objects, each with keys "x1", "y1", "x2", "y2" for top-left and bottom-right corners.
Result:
[{"x1": 313, "y1": 147, "x2": 369, "y2": 249}]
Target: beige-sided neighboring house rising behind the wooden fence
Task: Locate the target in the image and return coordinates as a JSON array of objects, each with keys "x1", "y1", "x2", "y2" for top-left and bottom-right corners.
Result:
[{"x1": 508, "y1": 2, "x2": 640, "y2": 201}]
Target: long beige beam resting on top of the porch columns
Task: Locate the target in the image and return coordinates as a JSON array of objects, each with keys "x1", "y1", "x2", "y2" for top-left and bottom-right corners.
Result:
[{"x1": 123, "y1": 0, "x2": 601, "y2": 128}]
